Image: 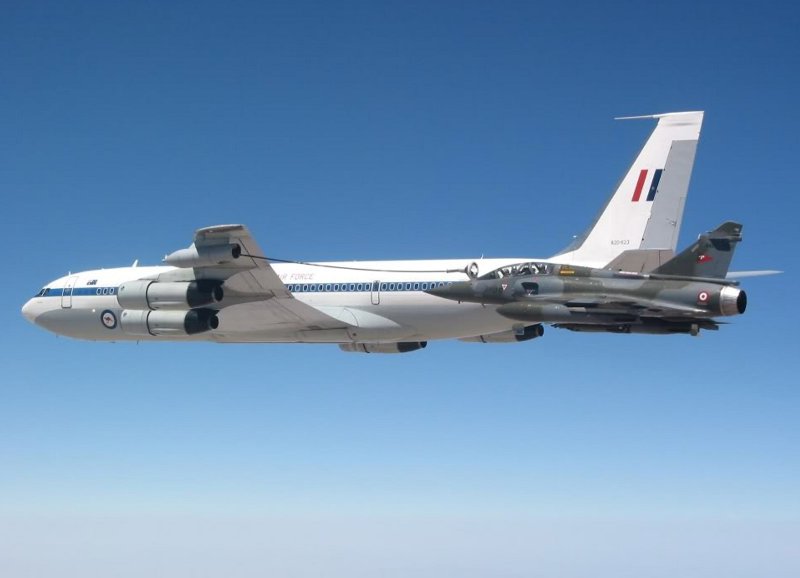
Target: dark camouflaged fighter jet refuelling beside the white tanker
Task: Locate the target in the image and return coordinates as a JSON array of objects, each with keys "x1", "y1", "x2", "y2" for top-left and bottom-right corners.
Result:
[{"x1": 427, "y1": 221, "x2": 747, "y2": 341}]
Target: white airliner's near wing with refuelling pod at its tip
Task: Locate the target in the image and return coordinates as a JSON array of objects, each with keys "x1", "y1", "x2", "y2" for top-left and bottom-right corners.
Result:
[{"x1": 165, "y1": 225, "x2": 349, "y2": 333}]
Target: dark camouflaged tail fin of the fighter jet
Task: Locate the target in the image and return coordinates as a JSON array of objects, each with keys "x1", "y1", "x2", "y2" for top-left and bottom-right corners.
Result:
[{"x1": 653, "y1": 221, "x2": 742, "y2": 279}]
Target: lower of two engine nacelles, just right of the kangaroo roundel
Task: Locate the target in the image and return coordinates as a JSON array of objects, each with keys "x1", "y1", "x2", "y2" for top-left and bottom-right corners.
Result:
[{"x1": 120, "y1": 309, "x2": 219, "y2": 336}]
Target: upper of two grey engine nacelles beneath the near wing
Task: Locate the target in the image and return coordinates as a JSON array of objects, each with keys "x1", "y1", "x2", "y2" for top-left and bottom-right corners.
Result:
[{"x1": 117, "y1": 280, "x2": 224, "y2": 310}]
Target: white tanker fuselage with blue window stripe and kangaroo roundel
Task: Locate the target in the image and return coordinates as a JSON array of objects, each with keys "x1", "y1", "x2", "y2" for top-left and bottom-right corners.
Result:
[{"x1": 23, "y1": 258, "x2": 546, "y2": 343}]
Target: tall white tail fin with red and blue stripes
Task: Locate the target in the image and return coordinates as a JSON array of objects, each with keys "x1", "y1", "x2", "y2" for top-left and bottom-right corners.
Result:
[{"x1": 553, "y1": 111, "x2": 703, "y2": 268}]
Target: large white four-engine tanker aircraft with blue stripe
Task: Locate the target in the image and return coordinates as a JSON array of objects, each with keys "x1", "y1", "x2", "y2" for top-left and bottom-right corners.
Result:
[{"x1": 22, "y1": 112, "x2": 728, "y2": 353}]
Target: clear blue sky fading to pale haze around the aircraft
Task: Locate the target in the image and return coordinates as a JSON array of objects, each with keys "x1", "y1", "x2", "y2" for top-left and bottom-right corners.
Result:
[{"x1": 0, "y1": 1, "x2": 800, "y2": 578}]
